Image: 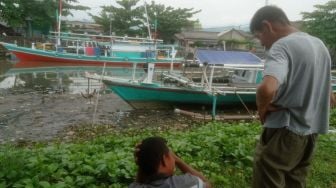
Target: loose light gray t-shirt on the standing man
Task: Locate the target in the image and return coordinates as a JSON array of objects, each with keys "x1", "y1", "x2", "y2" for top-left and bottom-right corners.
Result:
[{"x1": 264, "y1": 32, "x2": 331, "y2": 135}]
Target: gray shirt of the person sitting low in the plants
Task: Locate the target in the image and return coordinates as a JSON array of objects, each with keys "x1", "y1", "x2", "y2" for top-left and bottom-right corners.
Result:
[{"x1": 129, "y1": 173, "x2": 205, "y2": 188}]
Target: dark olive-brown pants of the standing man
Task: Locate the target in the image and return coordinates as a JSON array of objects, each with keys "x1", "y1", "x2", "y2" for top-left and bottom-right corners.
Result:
[{"x1": 252, "y1": 128, "x2": 317, "y2": 188}]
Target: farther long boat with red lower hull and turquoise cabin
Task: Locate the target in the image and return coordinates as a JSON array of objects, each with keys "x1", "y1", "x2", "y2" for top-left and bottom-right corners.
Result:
[{"x1": 0, "y1": 33, "x2": 183, "y2": 68}]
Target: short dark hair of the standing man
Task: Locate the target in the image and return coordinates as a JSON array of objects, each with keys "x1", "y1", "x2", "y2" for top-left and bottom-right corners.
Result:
[{"x1": 250, "y1": 6, "x2": 290, "y2": 33}]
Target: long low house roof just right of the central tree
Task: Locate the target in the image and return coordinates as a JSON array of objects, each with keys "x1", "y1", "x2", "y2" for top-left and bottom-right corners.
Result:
[{"x1": 175, "y1": 31, "x2": 219, "y2": 40}]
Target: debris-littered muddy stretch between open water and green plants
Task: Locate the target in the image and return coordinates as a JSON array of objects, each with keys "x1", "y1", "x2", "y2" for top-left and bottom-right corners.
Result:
[{"x1": 0, "y1": 92, "x2": 200, "y2": 143}]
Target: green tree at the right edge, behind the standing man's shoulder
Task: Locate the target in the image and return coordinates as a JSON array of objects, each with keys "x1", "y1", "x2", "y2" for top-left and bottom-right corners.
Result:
[{"x1": 302, "y1": 0, "x2": 336, "y2": 62}]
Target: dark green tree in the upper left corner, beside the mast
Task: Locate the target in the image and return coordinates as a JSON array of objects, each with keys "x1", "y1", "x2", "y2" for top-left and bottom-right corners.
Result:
[{"x1": 0, "y1": 0, "x2": 89, "y2": 34}]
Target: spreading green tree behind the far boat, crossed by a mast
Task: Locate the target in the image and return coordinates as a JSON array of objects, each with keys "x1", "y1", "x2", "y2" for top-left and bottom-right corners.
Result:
[{"x1": 91, "y1": 0, "x2": 199, "y2": 41}]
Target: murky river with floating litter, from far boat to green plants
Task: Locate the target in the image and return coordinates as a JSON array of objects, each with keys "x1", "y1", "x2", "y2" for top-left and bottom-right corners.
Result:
[{"x1": 0, "y1": 60, "x2": 207, "y2": 143}]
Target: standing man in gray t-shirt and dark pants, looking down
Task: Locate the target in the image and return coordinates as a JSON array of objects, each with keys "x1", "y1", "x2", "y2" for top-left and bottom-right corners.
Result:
[{"x1": 250, "y1": 6, "x2": 331, "y2": 188}]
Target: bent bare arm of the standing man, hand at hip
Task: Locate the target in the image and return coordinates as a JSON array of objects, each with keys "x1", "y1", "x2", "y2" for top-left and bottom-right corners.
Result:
[{"x1": 257, "y1": 76, "x2": 278, "y2": 124}]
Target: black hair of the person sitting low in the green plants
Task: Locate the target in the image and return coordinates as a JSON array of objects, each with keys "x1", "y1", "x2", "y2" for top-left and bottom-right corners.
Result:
[{"x1": 135, "y1": 137, "x2": 169, "y2": 183}]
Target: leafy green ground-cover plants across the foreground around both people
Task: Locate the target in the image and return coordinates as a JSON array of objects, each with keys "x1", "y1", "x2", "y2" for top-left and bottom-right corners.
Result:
[{"x1": 0, "y1": 119, "x2": 336, "y2": 187}]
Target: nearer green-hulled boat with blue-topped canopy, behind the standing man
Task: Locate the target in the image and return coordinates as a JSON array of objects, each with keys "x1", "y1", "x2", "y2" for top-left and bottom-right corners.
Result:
[{"x1": 87, "y1": 50, "x2": 263, "y2": 113}]
